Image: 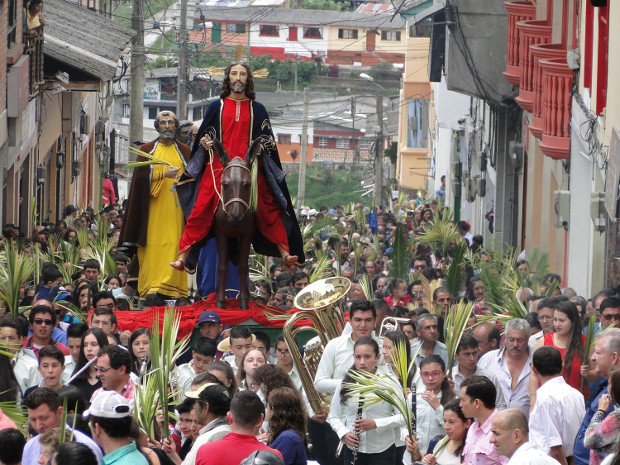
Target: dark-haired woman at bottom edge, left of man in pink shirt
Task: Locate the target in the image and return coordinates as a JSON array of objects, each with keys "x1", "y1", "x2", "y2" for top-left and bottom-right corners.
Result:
[{"x1": 406, "y1": 399, "x2": 473, "y2": 465}]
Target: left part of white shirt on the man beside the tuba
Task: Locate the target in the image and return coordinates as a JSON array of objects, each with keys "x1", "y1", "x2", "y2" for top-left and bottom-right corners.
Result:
[{"x1": 314, "y1": 334, "x2": 355, "y2": 394}]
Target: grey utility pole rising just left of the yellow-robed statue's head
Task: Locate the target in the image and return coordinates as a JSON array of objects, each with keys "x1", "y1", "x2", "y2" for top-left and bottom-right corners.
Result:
[{"x1": 129, "y1": 0, "x2": 144, "y2": 144}]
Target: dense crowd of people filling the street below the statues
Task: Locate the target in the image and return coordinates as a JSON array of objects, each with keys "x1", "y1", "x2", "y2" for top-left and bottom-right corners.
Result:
[{"x1": 0, "y1": 192, "x2": 620, "y2": 465}]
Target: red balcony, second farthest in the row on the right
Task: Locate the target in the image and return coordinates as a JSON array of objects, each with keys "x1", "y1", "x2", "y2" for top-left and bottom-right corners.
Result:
[{"x1": 515, "y1": 20, "x2": 551, "y2": 113}]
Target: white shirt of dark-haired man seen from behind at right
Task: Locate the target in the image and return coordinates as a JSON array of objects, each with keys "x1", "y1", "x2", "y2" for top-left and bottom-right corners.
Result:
[{"x1": 529, "y1": 376, "x2": 586, "y2": 457}]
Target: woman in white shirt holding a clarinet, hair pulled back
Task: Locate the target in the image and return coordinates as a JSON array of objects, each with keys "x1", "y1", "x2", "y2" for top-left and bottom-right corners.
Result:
[{"x1": 327, "y1": 337, "x2": 403, "y2": 465}]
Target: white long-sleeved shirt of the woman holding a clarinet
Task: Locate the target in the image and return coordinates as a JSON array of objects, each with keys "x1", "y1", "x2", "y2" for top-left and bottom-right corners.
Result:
[{"x1": 327, "y1": 372, "x2": 404, "y2": 454}]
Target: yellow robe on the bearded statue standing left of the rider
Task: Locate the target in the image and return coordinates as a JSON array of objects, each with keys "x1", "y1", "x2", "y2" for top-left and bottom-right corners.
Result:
[{"x1": 138, "y1": 143, "x2": 187, "y2": 297}]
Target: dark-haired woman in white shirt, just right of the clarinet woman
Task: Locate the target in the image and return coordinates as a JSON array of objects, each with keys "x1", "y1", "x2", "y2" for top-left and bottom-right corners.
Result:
[{"x1": 408, "y1": 354, "x2": 456, "y2": 451}]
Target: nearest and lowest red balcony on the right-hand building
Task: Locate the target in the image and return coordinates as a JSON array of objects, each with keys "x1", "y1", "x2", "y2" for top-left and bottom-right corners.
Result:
[{"x1": 540, "y1": 58, "x2": 573, "y2": 160}]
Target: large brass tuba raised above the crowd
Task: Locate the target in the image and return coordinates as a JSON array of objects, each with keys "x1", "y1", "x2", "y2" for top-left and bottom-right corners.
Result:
[{"x1": 282, "y1": 277, "x2": 351, "y2": 413}]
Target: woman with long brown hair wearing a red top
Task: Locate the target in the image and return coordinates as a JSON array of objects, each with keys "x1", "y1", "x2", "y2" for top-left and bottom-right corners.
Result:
[{"x1": 529, "y1": 301, "x2": 598, "y2": 398}]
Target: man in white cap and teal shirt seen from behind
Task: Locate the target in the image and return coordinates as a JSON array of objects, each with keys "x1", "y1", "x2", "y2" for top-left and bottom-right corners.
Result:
[{"x1": 82, "y1": 391, "x2": 148, "y2": 465}]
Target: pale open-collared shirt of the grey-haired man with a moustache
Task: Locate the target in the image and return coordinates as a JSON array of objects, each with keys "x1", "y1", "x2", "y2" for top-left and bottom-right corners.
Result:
[{"x1": 478, "y1": 347, "x2": 532, "y2": 418}]
